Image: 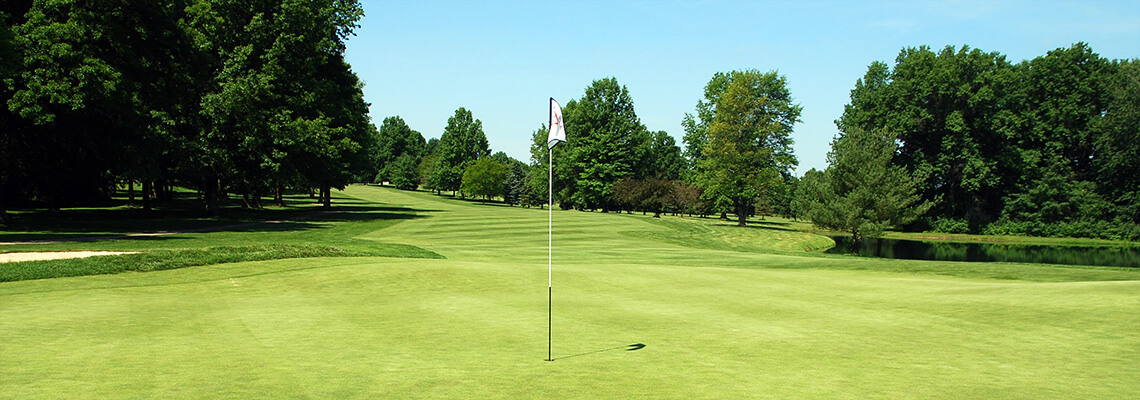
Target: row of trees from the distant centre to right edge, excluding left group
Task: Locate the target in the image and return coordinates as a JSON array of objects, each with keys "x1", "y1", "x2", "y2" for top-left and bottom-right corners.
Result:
[{"x1": 382, "y1": 43, "x2": 1140, "y2": 240}]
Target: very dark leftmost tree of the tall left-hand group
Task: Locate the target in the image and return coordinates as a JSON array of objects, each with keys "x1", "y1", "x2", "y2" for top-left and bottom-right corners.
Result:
[{"x1": 6, "y1": 1, "x2": 194, "y2": 206}]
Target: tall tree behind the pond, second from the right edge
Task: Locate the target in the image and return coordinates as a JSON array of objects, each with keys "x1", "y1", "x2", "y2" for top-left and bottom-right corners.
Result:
[{"x1": 1002, "y1": 43, "x2": 1112, "y2": 223}]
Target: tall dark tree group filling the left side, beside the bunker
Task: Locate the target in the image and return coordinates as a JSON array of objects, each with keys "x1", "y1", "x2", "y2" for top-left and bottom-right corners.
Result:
[{"x1": 0, "y1": 0, "x2": 377, "y2": 218}]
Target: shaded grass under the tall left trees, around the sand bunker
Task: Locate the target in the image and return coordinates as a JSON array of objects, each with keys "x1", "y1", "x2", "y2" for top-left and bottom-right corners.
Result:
[{"x1": 0, "y1": 190, "x2": 441, "y2": 281}]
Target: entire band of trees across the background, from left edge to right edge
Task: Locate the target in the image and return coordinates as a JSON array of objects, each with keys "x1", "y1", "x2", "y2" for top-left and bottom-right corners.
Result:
[{"x1": 0, "y1": 4, "x2": 1140, "y2": 246}]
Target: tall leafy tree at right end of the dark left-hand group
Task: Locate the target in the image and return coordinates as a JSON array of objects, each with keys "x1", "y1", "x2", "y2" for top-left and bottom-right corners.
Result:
[{"x1": 187, "y1": 0, "x2": 367, "y2": 211}]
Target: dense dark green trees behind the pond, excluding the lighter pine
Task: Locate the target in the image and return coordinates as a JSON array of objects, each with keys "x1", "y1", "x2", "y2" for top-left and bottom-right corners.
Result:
[{"x1": 836, "y1": 43, "x2": 1140, "y2": 238}]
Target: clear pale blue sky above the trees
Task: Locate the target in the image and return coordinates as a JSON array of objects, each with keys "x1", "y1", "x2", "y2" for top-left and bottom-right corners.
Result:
[{"x1": 348, "y1": 0, "x2": 1140, "y2": 175}]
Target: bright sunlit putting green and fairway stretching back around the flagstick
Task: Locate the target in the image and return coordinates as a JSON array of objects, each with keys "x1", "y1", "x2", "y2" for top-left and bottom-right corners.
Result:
[{"x1": 0, "y1": 186, "x2": 1140, "y2": 399}]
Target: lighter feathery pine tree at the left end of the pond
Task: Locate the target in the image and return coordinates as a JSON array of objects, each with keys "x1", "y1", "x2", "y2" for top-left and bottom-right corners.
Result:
[{"x1": 800, "y1": 128, "x2": 934, "y2": 246}]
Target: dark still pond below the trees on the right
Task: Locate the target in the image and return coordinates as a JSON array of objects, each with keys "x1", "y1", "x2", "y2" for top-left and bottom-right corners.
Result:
[{"x1": 827, "y1": 236, "x2": 1140, "y2": 268}]
